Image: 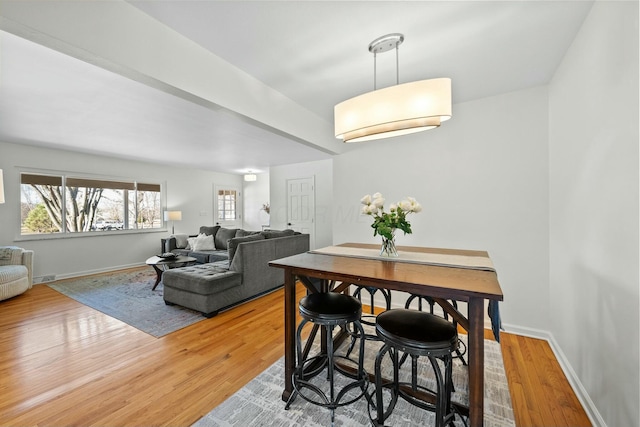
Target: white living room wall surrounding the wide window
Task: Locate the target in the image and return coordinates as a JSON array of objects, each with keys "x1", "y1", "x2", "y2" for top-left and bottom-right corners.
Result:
[{"x1": 0, "y1": 142, "x2": 242, "y2": 278}]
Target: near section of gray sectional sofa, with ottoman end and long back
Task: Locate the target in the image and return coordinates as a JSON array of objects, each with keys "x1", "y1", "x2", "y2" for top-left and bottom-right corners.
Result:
[{"x1": 162, "y1": 228, "x2": 309, "y2": 317}]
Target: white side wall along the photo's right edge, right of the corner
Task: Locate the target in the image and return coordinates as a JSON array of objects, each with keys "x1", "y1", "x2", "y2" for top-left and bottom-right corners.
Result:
[{"x1": 549, "y1": 2, "x2": 640, "y2": 426}]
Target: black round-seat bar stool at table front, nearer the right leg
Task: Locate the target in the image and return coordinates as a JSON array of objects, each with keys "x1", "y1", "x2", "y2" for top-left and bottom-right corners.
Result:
[{"x1": 369, "y1": 309, "x2": 458, "y2": 427}]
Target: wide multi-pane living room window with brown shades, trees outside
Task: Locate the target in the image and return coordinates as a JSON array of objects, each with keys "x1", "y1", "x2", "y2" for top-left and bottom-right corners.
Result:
[{"x1": 20, "y1": 173, "x2": 162, "y2": 235}]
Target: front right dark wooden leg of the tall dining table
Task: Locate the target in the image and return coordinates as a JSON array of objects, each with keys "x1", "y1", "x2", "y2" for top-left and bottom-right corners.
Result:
[{"x1": 468, "y1": 298, "x2": 484, "y2": 427}]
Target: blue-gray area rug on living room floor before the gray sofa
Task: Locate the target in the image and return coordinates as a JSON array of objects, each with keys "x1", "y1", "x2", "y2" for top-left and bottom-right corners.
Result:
[{"x1": 47, "y1": 268, "x2": 205, "y2": 338}]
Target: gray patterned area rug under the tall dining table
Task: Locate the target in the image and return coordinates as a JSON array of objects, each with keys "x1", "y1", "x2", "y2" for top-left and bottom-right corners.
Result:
[{"x1": 193, "y1": 335, "x2": 515, "y2": 427}]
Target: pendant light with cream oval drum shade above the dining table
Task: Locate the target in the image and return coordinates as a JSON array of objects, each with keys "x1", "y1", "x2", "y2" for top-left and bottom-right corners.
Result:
[{"x1": 334, "y1": 33, "x2": 451, "y2": 142}]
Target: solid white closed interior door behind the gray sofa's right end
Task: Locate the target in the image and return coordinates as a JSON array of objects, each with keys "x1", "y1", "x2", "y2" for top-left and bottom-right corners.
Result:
[{"x1": 287, "y1": 177, "x2": 316, "y2": 249}]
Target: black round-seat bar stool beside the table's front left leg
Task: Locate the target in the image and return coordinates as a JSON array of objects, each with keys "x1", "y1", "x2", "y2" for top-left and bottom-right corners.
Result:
[{"x1": 285, "y1": 292, "x2": 369, "y2": 423}]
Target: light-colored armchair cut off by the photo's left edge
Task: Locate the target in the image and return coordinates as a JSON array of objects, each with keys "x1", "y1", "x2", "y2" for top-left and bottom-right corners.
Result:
[{"x1": 0, "y1": 246, "x2": 33, "y2": 301}]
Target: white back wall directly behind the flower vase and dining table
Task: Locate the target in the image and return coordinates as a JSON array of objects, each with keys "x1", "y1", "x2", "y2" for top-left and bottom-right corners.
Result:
[{"x1": 333, "y1": 87, "x2": 550, "y2": 330}]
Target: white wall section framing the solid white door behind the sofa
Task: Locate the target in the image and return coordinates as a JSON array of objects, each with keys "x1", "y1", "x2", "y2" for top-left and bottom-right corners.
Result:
[{"x1": 269, "y1": 159, "x2": 334, "y2": 249}]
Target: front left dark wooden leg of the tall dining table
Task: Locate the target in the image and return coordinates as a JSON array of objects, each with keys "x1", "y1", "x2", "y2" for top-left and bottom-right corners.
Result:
[{"x1": 282, "y1": 269, "x2": 296, "y2": 402}]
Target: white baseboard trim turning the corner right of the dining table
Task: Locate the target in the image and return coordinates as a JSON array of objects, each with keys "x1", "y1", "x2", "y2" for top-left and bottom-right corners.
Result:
[{"x1": 503, "y1": 324, "x2": 607, "y2": 427}]
